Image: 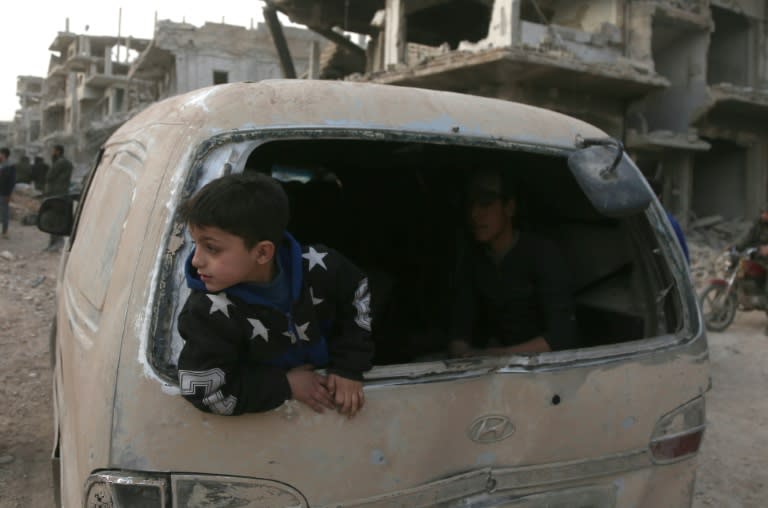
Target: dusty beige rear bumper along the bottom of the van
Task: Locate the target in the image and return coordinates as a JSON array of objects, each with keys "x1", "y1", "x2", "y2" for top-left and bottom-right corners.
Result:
[{"x1": 316, "y1": 450, "x2": 696, "y2": 508}]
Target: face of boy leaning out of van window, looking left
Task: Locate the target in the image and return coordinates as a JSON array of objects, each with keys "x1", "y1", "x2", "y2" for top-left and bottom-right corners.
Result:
[{"x1": 189, "y1": 225, "x2": 274, "y2": 292}]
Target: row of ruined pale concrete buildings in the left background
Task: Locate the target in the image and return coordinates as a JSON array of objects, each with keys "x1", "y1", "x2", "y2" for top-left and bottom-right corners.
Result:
[{"x1": 10, "y1": 21, "x2": 324, "y2": 180}]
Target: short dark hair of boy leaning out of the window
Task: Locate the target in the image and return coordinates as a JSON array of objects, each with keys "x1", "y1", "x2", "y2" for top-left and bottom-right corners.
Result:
[{"x1": 179, "y1": 173, "x2": 290, "y2": 249}]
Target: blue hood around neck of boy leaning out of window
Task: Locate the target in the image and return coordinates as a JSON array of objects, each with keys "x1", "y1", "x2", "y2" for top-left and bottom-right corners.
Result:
[{"x1": 184, "y1": 232, "x2": 303, "y2": 307}]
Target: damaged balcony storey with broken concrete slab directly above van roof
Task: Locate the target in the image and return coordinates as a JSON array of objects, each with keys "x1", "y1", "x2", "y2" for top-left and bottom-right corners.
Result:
[{"x1": 272, "y1": 0, "x2": 668, "y2": 97}]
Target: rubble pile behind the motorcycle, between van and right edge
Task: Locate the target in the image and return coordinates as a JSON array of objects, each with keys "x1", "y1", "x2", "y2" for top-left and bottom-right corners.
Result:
[{"x1": 686, "y1": 215, "x2": 752, "y2": 289}]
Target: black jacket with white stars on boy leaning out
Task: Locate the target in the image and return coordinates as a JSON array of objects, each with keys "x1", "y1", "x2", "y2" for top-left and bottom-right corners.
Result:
[{"x1": 178, "y1": 234, "x2": 373, "y2": 415}]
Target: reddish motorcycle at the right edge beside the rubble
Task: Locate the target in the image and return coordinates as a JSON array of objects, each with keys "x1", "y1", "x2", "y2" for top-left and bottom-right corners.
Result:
[{"x1": 700, "y1": 247, "x2": 768, "y2": 332}]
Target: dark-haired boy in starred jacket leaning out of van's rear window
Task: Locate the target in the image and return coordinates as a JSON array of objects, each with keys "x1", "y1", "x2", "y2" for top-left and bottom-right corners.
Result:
[{"x1": 178, "y1": 173, "x2": 373, "y2": 416}]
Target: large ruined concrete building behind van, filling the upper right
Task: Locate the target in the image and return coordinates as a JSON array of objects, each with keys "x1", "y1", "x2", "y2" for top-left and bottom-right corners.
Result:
[{"x1": 268, "y1": 0, "x2": 768, "y2": 224}]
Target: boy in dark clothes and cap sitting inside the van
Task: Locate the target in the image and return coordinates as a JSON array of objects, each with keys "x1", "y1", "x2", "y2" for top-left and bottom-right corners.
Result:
[{"x1": 450, "y1": 171, "x2": 575, "y2": 356}]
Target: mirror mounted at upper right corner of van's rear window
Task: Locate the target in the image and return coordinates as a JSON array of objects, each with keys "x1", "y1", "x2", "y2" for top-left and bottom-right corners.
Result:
[{"x1": 568, "y1": 138, "x2": 653, "y2": 218}]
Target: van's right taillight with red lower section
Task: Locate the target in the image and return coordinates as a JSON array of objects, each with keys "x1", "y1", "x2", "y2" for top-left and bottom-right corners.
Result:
[{"x1": 650, "y1": 397, "x2": 706, "y2": 463}]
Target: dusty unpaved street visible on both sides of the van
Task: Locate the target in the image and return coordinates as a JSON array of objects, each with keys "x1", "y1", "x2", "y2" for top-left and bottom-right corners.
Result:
[{"x1": 0, "y1": 216, "x2": 768, "y2": 508}]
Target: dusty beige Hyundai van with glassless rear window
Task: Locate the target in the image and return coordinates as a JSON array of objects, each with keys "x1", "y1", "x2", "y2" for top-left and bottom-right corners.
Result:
[{"x1": 46, "y1": 81, "x2": 708, "y2": 508}]
